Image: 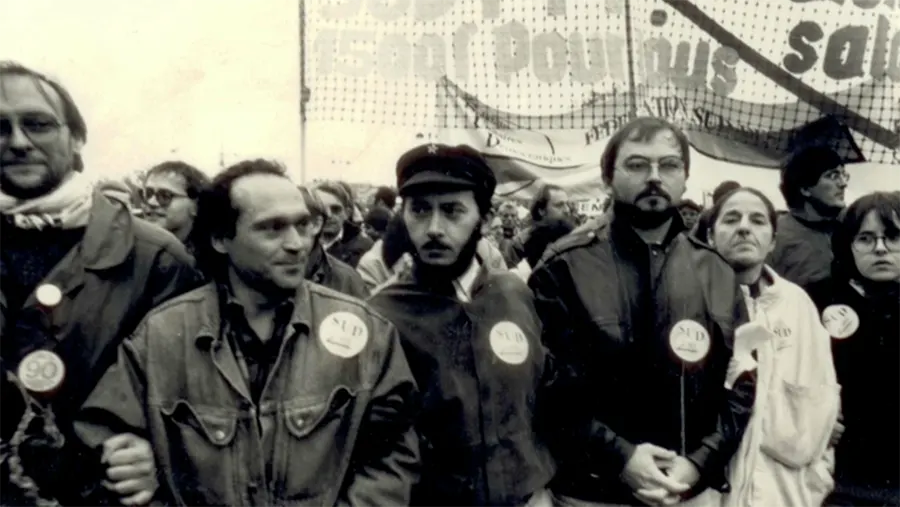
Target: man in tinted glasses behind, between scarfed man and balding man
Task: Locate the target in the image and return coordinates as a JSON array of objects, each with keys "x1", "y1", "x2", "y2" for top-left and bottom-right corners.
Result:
[{"x1": 140, "y1": 161, "x2": 209, "y2": 254}]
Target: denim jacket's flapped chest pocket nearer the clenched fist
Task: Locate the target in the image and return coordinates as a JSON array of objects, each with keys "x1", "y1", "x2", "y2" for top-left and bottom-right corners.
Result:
[{"x1": 160, "y1": 400, "x2": 237, "y2": 505}]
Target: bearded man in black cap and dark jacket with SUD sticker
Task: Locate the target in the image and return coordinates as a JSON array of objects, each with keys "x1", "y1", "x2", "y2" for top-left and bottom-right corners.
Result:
[{"x1": 370, "y1": 144, "x2": 555, "y2": 507}]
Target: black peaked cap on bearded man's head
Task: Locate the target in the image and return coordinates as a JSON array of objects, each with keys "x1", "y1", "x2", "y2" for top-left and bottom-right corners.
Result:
[{"x1": 397, "y1": 144, "x2": 497, "y2": 199}]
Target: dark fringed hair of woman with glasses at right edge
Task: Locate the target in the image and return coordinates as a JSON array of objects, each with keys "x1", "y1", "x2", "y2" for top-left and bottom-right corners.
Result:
[{"x1": 831, "y1": 192, "x2": 900, "y2": 281}]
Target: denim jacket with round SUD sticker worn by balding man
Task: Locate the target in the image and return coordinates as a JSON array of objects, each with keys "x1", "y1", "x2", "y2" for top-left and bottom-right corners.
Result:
[{"x1": 76, "y1": 283, "x2": 418, "y2": 507}]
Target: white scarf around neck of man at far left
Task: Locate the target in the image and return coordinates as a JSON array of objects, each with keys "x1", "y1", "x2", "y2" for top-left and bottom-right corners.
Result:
[{"x1": 0, "y1": 172, "x2": 93, "y2": 230}]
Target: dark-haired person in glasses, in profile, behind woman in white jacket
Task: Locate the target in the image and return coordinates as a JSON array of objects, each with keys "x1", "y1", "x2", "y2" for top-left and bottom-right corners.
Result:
[{"x1": 767, "y1": 146, "x2": 850, "y2": 287}]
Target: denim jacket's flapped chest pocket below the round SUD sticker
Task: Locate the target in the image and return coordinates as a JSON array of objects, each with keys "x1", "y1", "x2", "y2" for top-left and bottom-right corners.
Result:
[{"x1": 282, "y1": 386, "x2": 357, "y2": 501}]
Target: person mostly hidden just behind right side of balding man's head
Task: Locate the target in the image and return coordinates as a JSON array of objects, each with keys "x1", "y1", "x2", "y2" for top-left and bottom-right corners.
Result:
[{"x1": 299, "y1": 186, "x2": 369, "y2": 298}]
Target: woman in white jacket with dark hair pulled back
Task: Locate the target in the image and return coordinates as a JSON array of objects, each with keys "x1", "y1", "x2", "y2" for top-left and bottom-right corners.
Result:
[{"x1": 709, "y1": 188, "x2": 840, "y2": 507}]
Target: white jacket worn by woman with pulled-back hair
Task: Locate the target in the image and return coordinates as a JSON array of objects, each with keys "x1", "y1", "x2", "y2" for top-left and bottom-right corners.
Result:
[{"x1": 722, "y1": 266, "x2": 840, "y2": 507}]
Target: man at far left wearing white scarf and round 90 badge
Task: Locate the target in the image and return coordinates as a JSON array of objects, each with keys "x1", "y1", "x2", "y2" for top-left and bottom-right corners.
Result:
[{"x1": 0, "y1": 63, "x2": 200, "y2": 505}]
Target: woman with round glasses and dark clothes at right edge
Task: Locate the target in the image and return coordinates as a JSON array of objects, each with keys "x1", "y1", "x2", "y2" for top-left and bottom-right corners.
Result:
[{"x1": 808, "y1": 192, "x2": 900, "y2": 506}]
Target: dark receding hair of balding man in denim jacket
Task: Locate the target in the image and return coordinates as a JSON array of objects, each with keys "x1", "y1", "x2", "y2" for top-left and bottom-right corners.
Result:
[{"x1": 194, "y1": 159, "x2": 290, "y2": 278}]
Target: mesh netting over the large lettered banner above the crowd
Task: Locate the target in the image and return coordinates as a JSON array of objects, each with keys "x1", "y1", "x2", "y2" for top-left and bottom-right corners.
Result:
[{"x1": 301, "y1": 0, "x2": 900, "y2": 165}]
